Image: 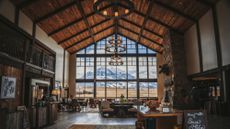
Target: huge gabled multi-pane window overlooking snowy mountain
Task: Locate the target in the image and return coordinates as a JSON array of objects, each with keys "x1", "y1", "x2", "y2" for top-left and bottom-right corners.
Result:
[{"x1": 76, "y1": 34, "x2": 157, "y2": 98}]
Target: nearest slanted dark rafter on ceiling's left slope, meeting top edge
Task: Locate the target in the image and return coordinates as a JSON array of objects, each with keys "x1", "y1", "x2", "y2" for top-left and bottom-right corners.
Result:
[{"x1": 35, "y1": 1, "x2": 76, "y2": 23}]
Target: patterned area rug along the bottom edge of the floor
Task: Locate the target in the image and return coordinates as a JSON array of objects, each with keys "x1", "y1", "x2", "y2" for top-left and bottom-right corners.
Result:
[{"x1": 68, "y1": 125, "x2": 135, "y2": 129}]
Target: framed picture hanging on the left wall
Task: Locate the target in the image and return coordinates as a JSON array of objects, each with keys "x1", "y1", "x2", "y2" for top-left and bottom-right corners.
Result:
[{"x1": 1, "y1": 76, "x2": 16, "y2": 99}]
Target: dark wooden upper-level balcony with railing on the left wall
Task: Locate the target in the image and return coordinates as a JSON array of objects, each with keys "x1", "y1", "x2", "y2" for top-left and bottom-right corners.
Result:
[{"x1": 0, "y1": 21, "x2": 55, "y2": 72}]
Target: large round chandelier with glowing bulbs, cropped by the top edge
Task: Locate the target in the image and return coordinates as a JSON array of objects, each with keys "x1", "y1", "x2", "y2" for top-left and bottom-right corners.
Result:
[{"x1": 93, "y1": 0, "x2": 134, "y2": 18}]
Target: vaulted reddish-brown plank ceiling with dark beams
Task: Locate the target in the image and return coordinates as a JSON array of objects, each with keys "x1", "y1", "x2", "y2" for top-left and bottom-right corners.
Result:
[{"x1": 12, "y1": 0, "x2": 217, "y2": 53}]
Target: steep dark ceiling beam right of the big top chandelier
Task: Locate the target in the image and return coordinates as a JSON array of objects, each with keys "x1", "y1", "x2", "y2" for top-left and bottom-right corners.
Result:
[{"x1": 137, "y1": 0, "x2": 153, "y2": 47}]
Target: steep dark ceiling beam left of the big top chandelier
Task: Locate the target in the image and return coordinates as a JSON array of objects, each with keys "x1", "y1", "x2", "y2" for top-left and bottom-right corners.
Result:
[{"x1": 77, "y1": 0, "x2": 95, "y2": 45}]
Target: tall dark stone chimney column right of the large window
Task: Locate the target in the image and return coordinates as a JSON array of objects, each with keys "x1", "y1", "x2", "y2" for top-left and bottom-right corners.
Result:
[{"x1": 163, "y1": 31, "x2": 192, "y2": 105}]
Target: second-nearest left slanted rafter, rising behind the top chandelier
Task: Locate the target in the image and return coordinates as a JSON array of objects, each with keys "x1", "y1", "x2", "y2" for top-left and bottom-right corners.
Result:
[{"x1": 48, "y1": 5, "x2": 113, "y2": 36}]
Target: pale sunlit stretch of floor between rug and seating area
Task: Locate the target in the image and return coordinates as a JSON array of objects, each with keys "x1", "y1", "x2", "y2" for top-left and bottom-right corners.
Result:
[{"x1": 45, "y1": 112, "x2": 136, "y2": 129}]
